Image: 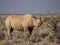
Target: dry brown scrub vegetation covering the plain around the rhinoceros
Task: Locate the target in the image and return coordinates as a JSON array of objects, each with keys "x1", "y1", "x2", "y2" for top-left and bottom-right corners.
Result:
[{"x1": 0, "y1": 15, "x2": 60, "y2": 45}]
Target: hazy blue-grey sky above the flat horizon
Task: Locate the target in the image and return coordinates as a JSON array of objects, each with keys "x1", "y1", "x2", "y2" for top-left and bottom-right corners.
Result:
[{"x1": 0, "y1": 0, "x2": 60, "y2": 14}]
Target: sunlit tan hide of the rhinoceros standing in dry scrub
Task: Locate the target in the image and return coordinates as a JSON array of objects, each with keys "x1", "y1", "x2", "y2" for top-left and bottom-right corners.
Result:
[{"x1": 5, "y1": 14, "x2": 41, "y2": 36}]
